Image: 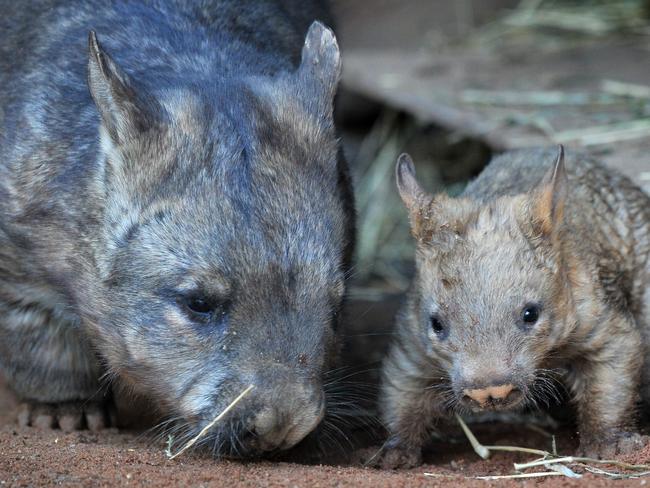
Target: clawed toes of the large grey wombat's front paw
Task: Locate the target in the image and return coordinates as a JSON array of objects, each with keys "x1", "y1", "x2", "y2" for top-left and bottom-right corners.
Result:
[{"x1": 18, "y1": 402, "x2": 110, "y2": 432}]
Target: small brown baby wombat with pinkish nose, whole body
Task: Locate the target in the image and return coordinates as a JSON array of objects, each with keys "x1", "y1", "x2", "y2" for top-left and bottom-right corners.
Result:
[{"x1": 382, "y1": 148, "x2": 650, "y2": 467}]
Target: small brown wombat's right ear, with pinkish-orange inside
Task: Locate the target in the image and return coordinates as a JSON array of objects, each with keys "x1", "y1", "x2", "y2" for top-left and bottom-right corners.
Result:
[{"x1": 532, "y1": 145, "x2": 569, "y2": 236}]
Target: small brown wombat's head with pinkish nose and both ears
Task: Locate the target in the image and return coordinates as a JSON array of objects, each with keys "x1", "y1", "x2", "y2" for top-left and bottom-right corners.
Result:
[{"x1": 397, "y1": 148, "x2": 567, "y2": 410}]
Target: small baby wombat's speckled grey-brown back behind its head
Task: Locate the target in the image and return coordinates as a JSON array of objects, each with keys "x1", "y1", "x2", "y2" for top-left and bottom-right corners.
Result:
[{"x1": 463, "y1": 148, "x2": 650, "y2": 317}]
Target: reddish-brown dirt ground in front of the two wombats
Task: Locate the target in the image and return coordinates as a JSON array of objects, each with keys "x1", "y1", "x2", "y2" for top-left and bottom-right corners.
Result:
[{"x1": 0, "y1": 372, "x2": 650, "y2": 487}]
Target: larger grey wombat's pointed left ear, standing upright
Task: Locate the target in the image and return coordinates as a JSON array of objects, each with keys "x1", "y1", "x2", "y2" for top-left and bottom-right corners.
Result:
[{"x1": 88, "y1": 31, "x2": 157, "y2": 144}]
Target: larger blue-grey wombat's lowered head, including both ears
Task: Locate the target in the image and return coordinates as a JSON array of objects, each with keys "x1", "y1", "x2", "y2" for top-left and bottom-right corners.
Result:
[{"x1": 86, "y1": 23, "x2": 352, "y2": 455}]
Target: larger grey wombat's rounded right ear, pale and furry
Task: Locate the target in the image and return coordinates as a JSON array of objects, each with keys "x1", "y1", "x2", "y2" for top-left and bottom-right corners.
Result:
[{"x1": 298, "y1": 21, "x2": 341, "y2": 112}]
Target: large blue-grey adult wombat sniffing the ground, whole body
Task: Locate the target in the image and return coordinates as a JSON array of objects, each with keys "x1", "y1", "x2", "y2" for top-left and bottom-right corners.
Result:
[{"x1": 0, "y1": 0, "x2": 353, "y2": 455}]
